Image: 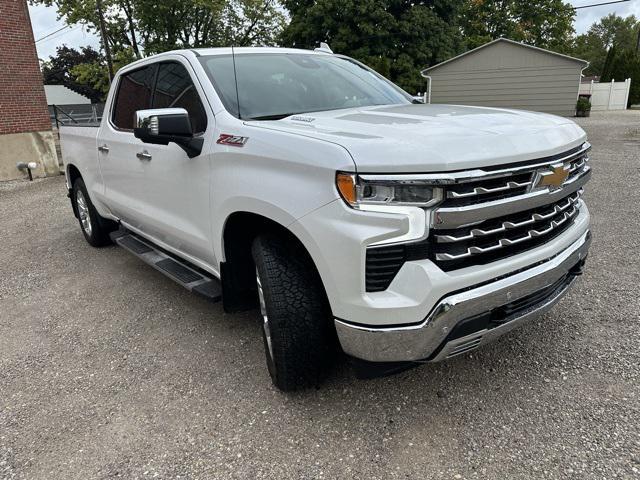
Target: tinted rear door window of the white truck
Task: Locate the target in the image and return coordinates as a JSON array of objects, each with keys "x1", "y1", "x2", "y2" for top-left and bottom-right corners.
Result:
[{"x1": 112, "y1": 65, "x2": 155, "y2": 130}]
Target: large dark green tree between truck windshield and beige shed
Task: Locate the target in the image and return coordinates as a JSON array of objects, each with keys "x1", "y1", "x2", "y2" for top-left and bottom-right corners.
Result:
[{"x1": 281, "y1": 0, "x2": 463, "y2": 93}]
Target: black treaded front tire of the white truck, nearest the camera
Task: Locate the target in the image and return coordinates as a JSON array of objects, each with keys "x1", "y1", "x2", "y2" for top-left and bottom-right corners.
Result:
[{"x1": 252, "y1": 234, "x2": 335, "y2": 391}]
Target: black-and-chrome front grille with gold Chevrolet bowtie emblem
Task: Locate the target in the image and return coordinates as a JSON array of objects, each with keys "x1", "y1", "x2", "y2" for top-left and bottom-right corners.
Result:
[{"x1": 428, "y1": 143, "x2": 591, "y2": 270}]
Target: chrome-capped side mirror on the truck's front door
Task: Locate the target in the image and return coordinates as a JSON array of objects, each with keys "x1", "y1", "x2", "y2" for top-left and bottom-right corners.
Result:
[{"x1": 133, "y1": 108, "x2": 204, "y2": 158}]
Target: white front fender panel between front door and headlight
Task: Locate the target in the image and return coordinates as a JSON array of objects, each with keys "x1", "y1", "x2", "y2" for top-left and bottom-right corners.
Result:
[{"x1": 211, "y1": 124, "x2": 355, "y2": 262}]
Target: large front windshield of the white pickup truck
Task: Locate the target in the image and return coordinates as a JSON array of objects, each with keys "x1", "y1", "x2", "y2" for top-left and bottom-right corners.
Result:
[{"x1": 199, "y1": 53, "x2": 411, "y2": 120}]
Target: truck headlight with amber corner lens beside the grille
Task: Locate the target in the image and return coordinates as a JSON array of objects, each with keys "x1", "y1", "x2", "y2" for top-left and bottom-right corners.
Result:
[{"x1": 336, "y1": 172, "x2": 443, "y2": 208}]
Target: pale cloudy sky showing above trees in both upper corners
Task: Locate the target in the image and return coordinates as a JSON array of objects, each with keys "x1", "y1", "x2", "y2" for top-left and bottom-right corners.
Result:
[{"x1": 29, "y1": 0, "x2": 640, "y2": 59}]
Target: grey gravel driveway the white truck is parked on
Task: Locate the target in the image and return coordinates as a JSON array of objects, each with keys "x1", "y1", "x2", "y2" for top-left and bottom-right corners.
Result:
[{"x1": 0, "y1": 112, "x2": 640, "y2": 479}]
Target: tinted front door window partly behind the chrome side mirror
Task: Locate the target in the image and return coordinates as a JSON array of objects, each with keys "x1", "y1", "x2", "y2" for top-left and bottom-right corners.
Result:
[{"x1": 153, "y1": 62, "x2": 207, "y2": 133}]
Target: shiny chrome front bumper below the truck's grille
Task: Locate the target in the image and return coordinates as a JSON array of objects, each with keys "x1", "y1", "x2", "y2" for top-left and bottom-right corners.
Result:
[{"x1": 335, "y1": 232, "x2": 591, "y2": 362}]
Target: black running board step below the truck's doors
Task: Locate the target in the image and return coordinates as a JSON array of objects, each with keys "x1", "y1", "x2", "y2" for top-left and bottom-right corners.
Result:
[{"x1": 110, "y1": 228, "x2": 222, "y2": 302}]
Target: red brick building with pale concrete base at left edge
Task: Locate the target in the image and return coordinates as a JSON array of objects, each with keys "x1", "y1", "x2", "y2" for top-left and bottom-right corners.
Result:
[{"x1": 0, "y1": 0, "x2": 59, "y2": 180}]
